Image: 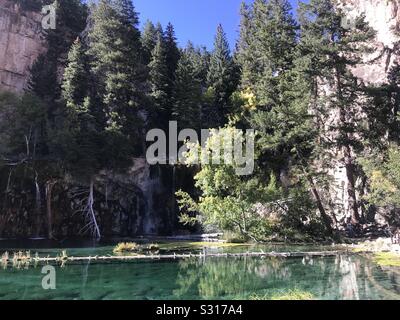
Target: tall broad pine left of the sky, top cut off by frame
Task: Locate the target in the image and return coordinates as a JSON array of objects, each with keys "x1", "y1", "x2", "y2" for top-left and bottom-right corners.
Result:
[{"x1": 89, "y1": 0, "x2": 145, "y2": 144}]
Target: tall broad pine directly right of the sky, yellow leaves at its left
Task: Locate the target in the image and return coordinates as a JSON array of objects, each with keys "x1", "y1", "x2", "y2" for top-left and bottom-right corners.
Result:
[{"x1": 236, "y1": 0, "x2": 338, "y2": 233}]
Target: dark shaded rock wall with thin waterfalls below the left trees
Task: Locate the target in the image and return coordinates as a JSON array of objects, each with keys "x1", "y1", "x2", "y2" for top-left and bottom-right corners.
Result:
[{"x1": 0, "y1": 158, "x2": 177, "y2": 239}]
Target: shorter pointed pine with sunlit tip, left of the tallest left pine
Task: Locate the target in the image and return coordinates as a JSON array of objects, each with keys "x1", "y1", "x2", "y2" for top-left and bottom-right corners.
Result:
[{"x1": 59, "y1": 40, "x2": 107, "y2": 181}]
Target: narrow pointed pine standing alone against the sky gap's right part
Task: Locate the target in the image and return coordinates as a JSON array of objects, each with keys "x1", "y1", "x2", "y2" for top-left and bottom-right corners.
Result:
[{"x1": 207, "y1": 25, "x2": 237, "y2": 126}]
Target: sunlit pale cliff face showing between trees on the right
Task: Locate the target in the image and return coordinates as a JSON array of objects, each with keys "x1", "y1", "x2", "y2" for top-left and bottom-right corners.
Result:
[{"x1": 328, "y1": 0, "x2": 400, "y2": 219}]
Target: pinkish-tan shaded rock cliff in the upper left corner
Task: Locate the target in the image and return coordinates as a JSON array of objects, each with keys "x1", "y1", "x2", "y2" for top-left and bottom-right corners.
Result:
[{"x1": 0, "y1": 0, "x2": 46, "y2": 92}]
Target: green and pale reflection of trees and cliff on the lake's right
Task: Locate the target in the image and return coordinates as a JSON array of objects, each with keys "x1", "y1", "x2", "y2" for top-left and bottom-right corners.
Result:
[{"x1": 173, "y1": 255, "x2": 400, "y2": 300}]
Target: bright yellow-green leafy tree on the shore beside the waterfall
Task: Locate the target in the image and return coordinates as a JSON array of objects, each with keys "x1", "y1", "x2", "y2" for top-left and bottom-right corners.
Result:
[{"x1": 177, "y1": 128, "x2": 282, "y2": 241}]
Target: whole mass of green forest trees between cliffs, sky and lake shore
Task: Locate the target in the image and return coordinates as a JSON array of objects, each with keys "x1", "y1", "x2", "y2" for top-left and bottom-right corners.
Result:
[{"x1": 0, "y1": 0, "x2": 400, "y2": 240}]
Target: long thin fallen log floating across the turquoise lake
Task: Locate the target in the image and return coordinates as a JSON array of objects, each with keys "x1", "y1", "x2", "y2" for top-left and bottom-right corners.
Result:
[{"x1": 1, "y1": 251, "x2": 352, "y2": 265}]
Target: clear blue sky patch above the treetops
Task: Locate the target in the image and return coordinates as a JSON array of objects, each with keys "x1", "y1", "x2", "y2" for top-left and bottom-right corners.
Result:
[{"x1": 133, "y1": 0, "x2": 297, "y2": 49}]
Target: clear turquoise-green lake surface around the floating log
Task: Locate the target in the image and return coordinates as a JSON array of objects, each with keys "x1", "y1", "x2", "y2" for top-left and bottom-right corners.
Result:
[{"x1": 0, "y1": 241, "x2": 400, "y2": 300}]
